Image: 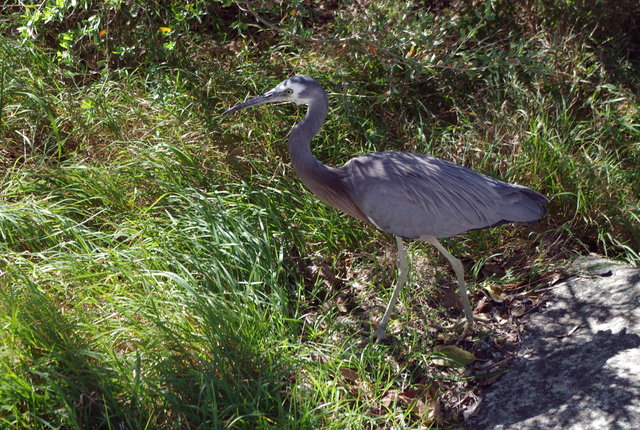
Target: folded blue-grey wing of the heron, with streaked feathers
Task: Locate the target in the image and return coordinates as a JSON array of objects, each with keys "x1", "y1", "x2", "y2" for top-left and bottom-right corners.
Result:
[{"x1": 340, "y1": 152, "x2": 546, "y2": 238}]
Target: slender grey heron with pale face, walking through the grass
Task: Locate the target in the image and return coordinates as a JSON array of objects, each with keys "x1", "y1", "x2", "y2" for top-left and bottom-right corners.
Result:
[{"x1": 223, "y1": 75, "x2": 548, "y2": 342}]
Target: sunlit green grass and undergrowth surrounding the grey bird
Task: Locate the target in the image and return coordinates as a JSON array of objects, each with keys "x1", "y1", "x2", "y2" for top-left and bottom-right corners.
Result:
[{"x1": 0, "y1": 1, "x2": 640, "y2": 429}]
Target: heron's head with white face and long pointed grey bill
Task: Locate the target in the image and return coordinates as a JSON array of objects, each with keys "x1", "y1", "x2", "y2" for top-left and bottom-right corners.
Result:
[{"x1": 223, "y1": 75, "x2": 326, "y2": 115}]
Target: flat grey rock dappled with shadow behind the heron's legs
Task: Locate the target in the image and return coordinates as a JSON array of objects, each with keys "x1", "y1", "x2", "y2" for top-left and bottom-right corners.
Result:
[{"x1": 466, "y1": 257, "x2": 640, "y2": 430}]
